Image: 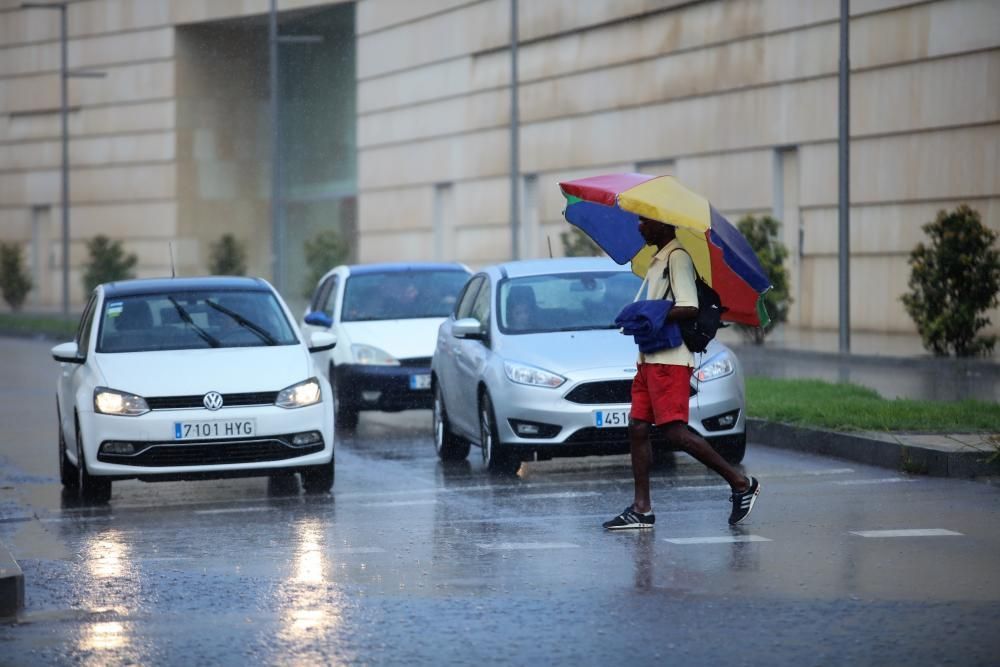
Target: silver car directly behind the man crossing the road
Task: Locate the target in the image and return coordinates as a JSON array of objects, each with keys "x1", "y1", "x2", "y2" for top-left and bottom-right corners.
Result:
[{"x1": 431, "y1": 258, "x2": 746, "y2": 474}]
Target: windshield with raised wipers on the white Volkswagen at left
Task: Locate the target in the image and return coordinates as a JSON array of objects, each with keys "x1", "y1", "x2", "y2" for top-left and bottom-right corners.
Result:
[{"x1": 97, "y1": 290, "x2": 298, "y2": 353}]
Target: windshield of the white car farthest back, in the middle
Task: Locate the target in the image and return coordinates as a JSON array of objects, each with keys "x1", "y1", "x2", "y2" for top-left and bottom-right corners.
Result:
[{"x1": 340, "y1": 271, "x2": 469, "y2": 322}]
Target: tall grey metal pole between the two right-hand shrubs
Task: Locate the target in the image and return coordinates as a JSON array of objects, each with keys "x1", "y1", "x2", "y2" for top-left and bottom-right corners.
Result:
[{"x1": 837, "y1": 0, "x2": 851, "y2": 353}]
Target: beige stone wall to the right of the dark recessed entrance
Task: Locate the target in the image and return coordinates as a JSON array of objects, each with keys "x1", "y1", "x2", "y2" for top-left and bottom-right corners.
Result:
[{"x1": 357, "y1": 0, "x2": 1000, "y2": 331}]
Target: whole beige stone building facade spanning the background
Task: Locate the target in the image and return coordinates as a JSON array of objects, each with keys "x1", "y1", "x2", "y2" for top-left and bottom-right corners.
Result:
[{"x1": 0, "y1": 0, "x2": 1000, "y2": 332}]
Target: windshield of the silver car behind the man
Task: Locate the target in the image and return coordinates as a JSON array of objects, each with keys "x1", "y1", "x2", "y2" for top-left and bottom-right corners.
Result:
[{"x1": 497, "y1": 271, "x2": 642, "y2": 334}]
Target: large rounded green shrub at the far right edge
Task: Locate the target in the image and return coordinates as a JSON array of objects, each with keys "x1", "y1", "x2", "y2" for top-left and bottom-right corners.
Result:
[{"x1": 901, "y1": 204, "x2": 1000, "y2": 357}]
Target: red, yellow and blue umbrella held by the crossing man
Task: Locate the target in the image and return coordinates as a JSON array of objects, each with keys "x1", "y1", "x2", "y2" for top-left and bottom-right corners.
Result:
[{"x1": 559, "y1": 174, "x2": 771, "y2": 326}]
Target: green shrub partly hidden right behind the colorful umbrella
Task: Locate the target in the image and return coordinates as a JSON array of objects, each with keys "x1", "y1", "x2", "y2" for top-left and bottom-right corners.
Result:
[{"x1": 736, "y1": 215, "x2": 792, "y2": 345}]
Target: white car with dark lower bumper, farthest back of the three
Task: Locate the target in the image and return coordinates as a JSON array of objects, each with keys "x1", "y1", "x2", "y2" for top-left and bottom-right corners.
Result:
[{"x1": 302, "y1": 262, "x2": 470, "y2": 429}]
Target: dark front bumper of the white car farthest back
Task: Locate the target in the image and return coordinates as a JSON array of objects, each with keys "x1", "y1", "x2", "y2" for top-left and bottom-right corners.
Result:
[{"x1": 336, "y1": 359, "x2": 433, "y2": 412}]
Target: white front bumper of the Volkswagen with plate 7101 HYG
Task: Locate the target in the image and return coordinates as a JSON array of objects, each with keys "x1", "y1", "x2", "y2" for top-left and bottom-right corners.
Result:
[{"x1": 80, "y1": 400, "x2": 333, "y2": 479}]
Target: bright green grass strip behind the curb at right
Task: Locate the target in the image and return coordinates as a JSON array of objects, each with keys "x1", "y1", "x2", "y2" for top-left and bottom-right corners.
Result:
[{"x1": 746, "y1": 377, "x2": 1000, "y2": 433}]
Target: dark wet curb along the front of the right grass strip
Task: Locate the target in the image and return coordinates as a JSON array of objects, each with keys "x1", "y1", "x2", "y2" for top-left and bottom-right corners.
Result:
[{"x1": 747, "y1": 418, "x2": 1000, "y2": 479}]
